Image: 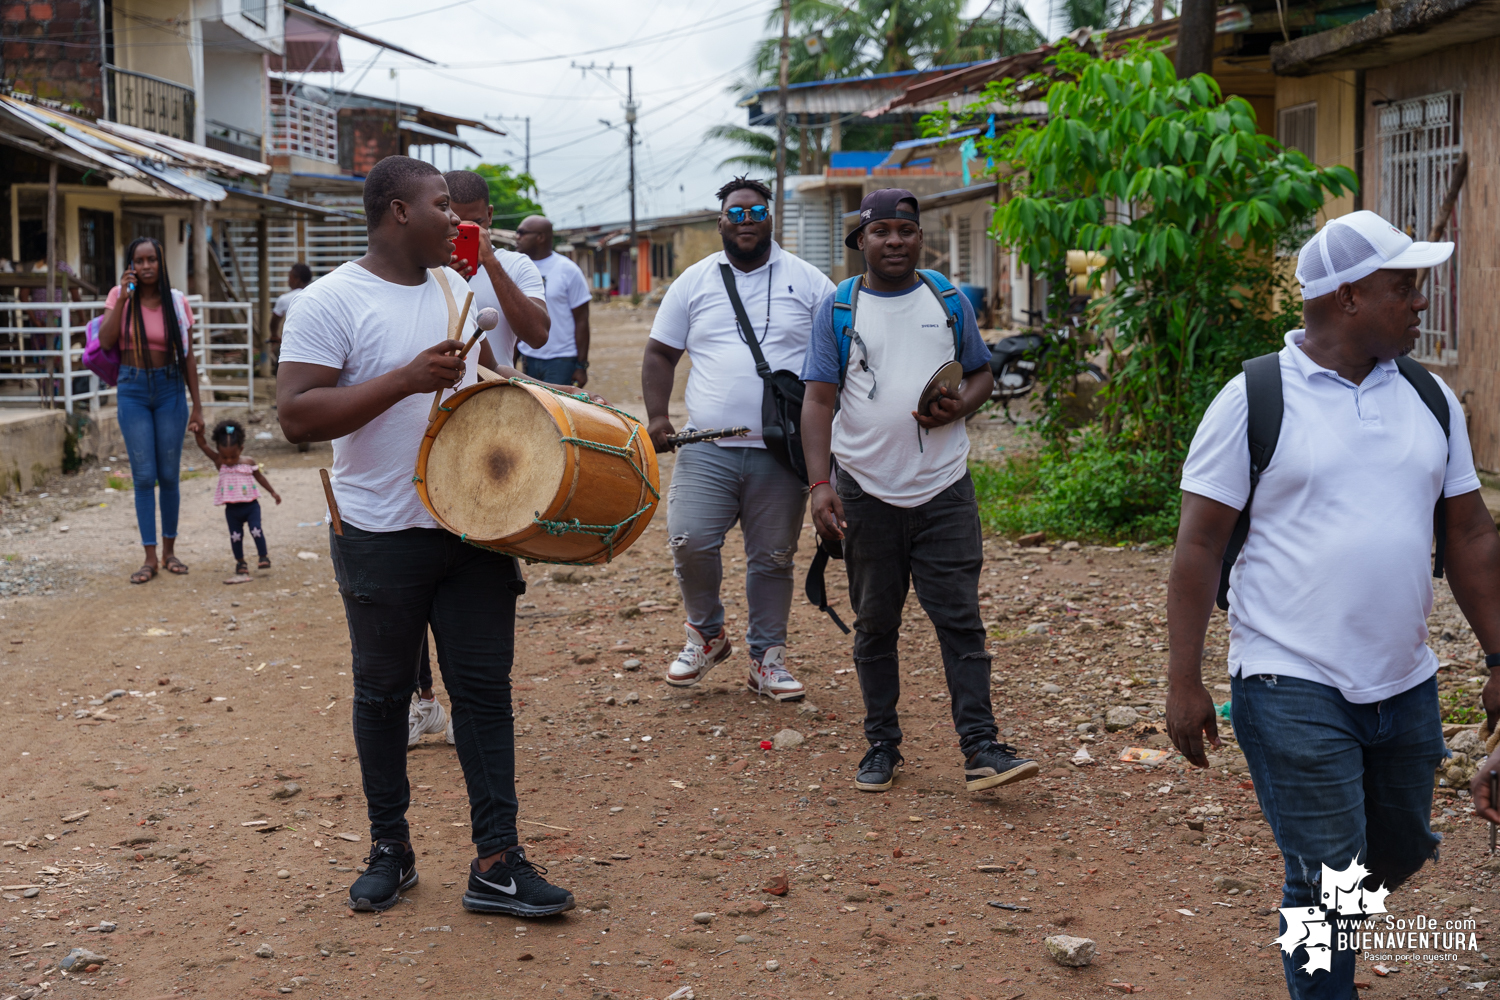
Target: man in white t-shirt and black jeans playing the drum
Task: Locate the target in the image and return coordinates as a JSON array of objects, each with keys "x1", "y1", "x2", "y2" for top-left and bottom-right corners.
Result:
[{"x1": 276, "y1": 156, "x2": 573, "y2": 918}]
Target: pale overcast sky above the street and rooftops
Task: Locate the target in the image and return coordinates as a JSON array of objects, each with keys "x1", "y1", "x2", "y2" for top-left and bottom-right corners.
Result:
[{"x1": 306, "y1": 0, "x2": 1047, "y2": 226}]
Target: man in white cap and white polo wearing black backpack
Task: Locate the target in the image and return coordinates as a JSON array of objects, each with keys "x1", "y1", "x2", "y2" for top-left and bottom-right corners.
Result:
[{"x1": 1167, "y1": 211, "x2": 1500, "y2": 1000}]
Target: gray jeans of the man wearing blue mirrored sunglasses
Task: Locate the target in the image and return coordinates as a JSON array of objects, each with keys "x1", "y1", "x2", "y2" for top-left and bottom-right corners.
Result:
[{"x1": 666, "y1": 442, "x2": 807, "y2": 660}]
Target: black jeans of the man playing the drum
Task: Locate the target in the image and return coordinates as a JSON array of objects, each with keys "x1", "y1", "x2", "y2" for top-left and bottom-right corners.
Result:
[{"x1": 330, "y1": 522, "x2": 527, "y2": 858}]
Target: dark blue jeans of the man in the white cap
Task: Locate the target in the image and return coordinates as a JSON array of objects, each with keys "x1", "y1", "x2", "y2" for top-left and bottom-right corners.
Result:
[{"x1": 1230, "y1": 673, "x2": 1448, "y2": 1000}]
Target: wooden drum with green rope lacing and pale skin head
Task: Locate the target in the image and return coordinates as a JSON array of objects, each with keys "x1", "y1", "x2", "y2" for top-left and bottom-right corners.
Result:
[{"x1": 416, "y1": 379, "x2": 662, "y2": 564}]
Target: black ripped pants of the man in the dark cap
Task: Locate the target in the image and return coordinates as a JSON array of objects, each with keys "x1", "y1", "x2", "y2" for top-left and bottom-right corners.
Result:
[{"x1": 837, "y1": 471, "x2": 996, "y2": 757}]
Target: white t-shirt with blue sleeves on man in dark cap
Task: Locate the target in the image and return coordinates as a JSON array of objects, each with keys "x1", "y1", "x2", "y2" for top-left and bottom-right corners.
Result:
[{"x1": 803, "y1": 282, "x2": 990, "y2": 507}]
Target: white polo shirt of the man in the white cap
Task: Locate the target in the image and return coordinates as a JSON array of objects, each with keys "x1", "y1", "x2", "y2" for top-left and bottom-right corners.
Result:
[{"x1": 1182, "y1": 330, "x2": 1479, "y2": 705}]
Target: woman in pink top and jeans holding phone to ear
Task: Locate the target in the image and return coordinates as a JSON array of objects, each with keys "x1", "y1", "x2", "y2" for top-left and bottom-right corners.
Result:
[{"x1": 99, "y1": 237, "x2": 204, "y2": 583}]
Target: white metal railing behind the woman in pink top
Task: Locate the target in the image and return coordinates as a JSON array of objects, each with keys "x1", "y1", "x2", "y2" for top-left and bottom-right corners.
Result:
[{"x1": 0, "y1": 295, "x2": 255, "y2": 414}]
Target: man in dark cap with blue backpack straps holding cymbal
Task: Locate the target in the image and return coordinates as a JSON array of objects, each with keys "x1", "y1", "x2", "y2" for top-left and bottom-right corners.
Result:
[{"x1": 803, "y1": 187, "x2": 1038, "y2": 792}]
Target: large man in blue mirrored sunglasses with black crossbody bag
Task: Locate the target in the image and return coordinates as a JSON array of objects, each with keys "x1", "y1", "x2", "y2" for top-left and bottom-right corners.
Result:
[{"x1": 641, "y1": 177, "x2": 833, "y2": 700}]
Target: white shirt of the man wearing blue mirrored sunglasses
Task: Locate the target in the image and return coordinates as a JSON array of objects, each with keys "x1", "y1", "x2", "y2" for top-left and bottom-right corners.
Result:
[{"x1": 651, "y1": 243, "x2": 834, "y2": 448}]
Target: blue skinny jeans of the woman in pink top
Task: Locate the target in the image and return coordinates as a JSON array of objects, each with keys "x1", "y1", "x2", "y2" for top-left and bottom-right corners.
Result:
[{"x1": 116, "y1": 364, "x2": 188, "y2": 547}]
